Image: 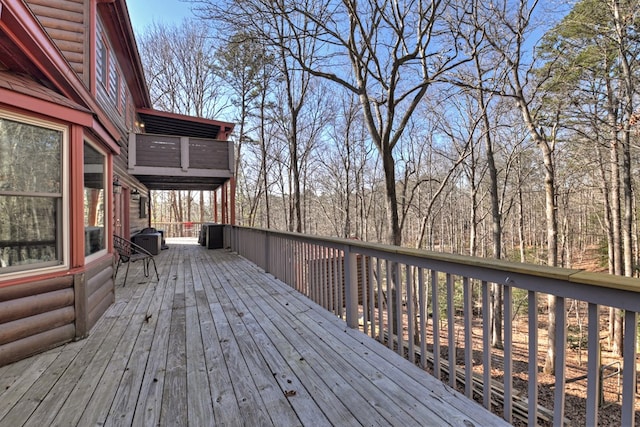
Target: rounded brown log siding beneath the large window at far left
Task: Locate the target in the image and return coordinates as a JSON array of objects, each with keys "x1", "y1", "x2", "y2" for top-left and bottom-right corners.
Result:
[{"x1": 0, "y1": 275, "x2": 76, "y2": 366}]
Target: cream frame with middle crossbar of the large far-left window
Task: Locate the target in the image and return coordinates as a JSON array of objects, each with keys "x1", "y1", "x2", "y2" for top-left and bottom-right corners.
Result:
[{"x1": 0, "y1": 109, "x2": 71, "y2": 282}]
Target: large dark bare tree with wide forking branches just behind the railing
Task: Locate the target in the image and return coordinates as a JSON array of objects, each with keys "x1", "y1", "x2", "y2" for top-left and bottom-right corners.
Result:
[{"x1": 202, "y1": 0, "x2": 466, "y2": 245}]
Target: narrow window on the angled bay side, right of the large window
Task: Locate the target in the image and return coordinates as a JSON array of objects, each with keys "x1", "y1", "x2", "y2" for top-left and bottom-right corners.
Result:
[{"x1": 84, "y1": 142, "x2": 107, "y2": 256}]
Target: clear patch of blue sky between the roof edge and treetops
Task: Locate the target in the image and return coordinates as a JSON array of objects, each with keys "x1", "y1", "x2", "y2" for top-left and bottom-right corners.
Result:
[{"x1": 127, "y1": 0, "x2": 193, "y2": 34}]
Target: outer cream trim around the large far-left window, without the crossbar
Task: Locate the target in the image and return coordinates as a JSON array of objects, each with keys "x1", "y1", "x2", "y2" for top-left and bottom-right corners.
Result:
[{"x1": 0, "y1": 110, "x2": 71, "y2": 282}]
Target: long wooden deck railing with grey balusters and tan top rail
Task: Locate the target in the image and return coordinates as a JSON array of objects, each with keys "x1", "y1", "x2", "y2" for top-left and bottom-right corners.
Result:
[{"x1": 225, "y1": 227, "x2": 640, "y2": 426}]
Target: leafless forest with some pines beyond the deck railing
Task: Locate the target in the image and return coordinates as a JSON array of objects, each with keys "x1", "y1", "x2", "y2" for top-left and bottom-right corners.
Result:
[{"x1": 138, "y1": 0, "x2": 640, "y2": 275}]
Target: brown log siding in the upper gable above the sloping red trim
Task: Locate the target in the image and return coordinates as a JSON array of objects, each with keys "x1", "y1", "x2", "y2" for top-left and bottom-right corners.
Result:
[{"x1": 26, "y1": 0, "x2": 90, "y2": 86}]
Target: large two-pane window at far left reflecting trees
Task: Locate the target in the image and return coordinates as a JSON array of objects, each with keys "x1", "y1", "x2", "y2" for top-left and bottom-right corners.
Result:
[{"x1": 0, "y1": 115, "x2": 67, "y2": 276}]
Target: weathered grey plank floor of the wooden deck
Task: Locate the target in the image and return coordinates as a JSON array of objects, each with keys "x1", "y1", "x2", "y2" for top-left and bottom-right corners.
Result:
[{"x1": 0, "y1": 240, "x2": 507, "y2": 427}]
